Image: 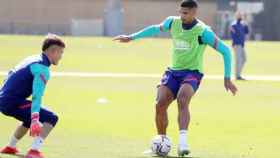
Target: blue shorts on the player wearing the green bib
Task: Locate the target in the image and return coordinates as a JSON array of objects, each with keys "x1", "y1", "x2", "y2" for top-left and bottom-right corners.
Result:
[{"x1": 161, "y1": 68, "x2": 203, "y2": 98}]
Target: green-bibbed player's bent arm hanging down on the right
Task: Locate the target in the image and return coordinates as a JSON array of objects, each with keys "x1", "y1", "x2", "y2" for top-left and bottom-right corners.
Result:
[{"x1": 202, "y1": 29, "x2": 237, "y2": 95}]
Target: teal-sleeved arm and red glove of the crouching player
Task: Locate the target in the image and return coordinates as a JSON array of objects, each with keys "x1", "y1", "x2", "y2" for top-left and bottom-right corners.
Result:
[{"x1": 30, "y1": 64, "x2": 49, "y2": 137}]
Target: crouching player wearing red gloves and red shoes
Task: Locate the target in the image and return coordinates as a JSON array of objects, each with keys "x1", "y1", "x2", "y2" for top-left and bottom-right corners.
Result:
[{"x1": 0, "y1": 34, "x2": 65, "y2": 158}]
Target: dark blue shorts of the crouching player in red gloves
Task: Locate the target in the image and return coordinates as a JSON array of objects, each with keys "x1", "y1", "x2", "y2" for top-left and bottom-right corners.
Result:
[{"x1": 1, "y1": 100, "x2": 58, "y2": 128}]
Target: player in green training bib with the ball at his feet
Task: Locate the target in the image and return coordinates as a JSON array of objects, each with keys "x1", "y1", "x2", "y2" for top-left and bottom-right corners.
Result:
[{"x1": 114, "y1": 0, "x2": 237, "y2": 156}]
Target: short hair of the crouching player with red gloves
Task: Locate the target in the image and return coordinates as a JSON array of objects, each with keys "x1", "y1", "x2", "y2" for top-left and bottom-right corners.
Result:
[{"x1": 42, "y1": 34, "x2": 65, "y2": 52}]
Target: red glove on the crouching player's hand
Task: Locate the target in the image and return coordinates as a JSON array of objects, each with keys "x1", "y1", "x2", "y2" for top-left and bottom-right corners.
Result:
[{"x1": 30, "y1": 113, "x2": 42, "y2": 137}]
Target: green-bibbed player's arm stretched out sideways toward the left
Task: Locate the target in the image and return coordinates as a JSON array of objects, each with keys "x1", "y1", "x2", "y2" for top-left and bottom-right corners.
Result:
[{"x1": 113, "y1": 17, "x2": 173, "y2": 43}]
